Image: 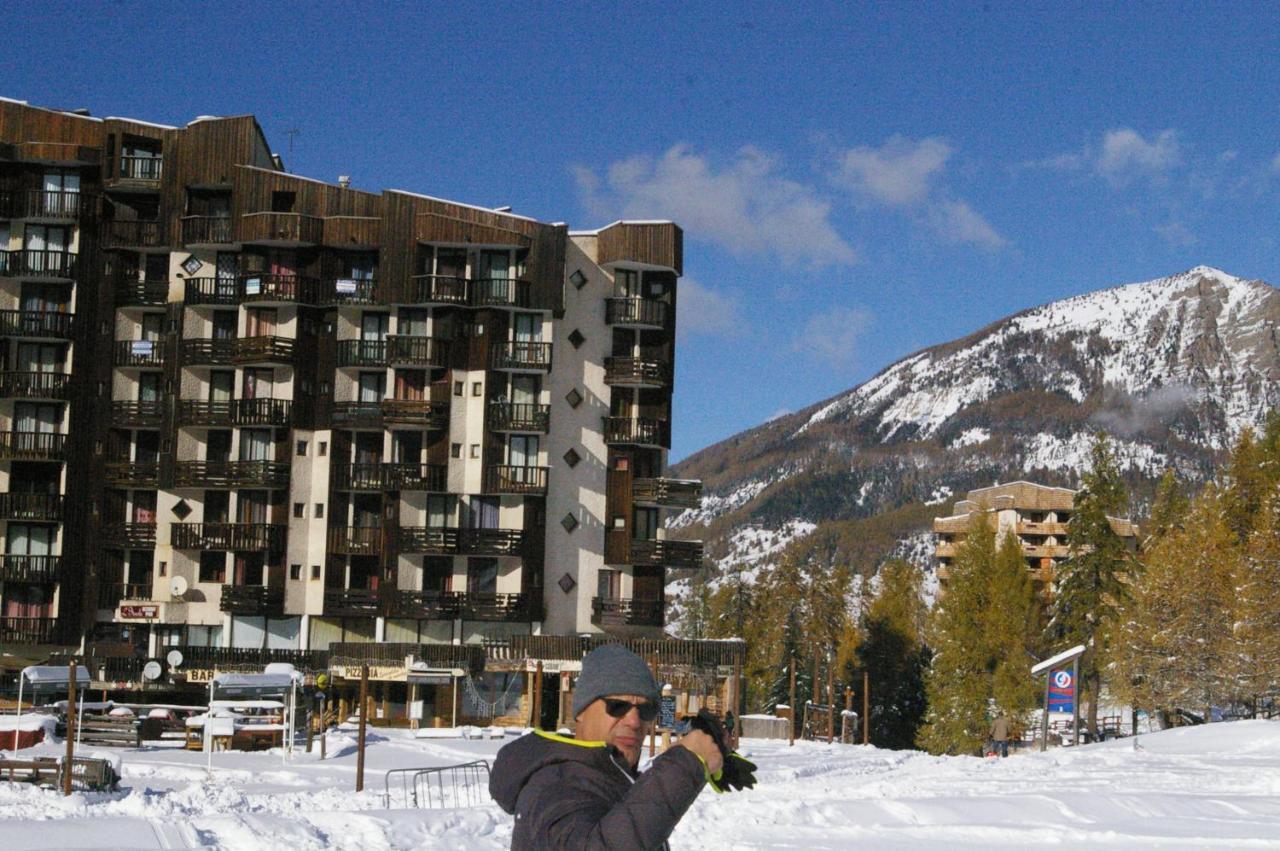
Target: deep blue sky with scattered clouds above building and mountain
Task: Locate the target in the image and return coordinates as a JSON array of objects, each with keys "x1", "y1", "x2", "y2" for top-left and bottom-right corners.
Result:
[{"x1": 10, "y1": 0, "x2": 1280, "y2": 459}]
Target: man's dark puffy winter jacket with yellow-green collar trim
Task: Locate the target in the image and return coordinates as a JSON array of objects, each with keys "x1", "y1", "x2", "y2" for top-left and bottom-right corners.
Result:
[{"x1": 489, "y1": 731, "x2": 707, "y2": 851}]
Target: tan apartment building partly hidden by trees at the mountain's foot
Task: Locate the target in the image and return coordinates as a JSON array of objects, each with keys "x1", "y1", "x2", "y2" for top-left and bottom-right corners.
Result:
[{"x1": 933, "y1": 481, "x2": 1138, "y2": 594}]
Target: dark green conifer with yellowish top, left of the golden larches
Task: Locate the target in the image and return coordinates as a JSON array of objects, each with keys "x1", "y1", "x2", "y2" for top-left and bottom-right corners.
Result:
[{"x1": 846, "y1": 559, "x2": 929, "y2": 749}]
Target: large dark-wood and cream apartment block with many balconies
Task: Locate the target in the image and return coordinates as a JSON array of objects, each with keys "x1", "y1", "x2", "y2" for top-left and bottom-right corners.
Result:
[{"x1": 0, "y1": 100, "x2": 703, "y2": 659}]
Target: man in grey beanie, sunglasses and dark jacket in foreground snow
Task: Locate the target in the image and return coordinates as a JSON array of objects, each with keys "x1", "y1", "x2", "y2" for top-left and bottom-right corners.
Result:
[{"x1": 489, "y1": 644, "x2": 723, "y2": 850}]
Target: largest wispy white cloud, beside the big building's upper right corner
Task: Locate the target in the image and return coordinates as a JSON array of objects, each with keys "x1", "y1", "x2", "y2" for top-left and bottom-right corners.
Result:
[{"x1": 573, "y1": 145, "x2": 856, "y2": 267}]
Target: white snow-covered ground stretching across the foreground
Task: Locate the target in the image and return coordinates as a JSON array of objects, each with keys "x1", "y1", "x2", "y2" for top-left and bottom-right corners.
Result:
[{"x1": 0, "y1": 720, "x2": 1280, "y2": 851}]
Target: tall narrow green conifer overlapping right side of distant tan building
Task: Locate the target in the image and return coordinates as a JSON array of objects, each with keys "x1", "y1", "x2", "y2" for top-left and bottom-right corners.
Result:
[{"x1": 1046, "y1": 433, "x2": 1134, "y2": 737}]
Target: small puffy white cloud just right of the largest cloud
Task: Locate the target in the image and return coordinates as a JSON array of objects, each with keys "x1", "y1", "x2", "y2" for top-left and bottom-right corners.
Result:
[{"x1": 835, "y1": 136, "x2": 951, "y2": 207}]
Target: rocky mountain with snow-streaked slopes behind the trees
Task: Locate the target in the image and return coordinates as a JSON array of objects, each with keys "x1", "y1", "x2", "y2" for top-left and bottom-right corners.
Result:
[{"x1": 672, "y1": 266, "x2": 1280, "y2": 583}]
